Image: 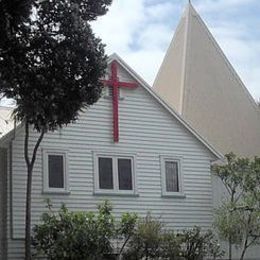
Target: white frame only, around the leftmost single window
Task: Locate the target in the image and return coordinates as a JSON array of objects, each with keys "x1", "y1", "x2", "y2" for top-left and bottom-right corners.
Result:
[{"x1": 42, "y1": 149, "x2": 69, "y2": 194}]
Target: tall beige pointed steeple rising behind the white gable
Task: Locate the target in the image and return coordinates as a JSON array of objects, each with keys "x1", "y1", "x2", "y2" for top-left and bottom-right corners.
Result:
[{"x1": 154, "y1": 3, "x2": 260, "y2": 156}]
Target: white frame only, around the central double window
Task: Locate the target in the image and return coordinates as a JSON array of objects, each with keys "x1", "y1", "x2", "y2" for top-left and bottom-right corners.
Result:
[{"x1": 93, "y1": 152, "x2": 138, "y2": 196}]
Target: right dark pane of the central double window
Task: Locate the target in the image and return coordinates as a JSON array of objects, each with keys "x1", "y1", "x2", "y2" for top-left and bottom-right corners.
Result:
[{"x1": 118, "y1": 159, "x2": 133, "y2": 190}]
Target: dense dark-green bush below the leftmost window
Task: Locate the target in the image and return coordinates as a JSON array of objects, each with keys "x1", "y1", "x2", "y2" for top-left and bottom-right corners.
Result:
[{"x1": 33, "y1": 202, "x2": 115, "y2": 260}]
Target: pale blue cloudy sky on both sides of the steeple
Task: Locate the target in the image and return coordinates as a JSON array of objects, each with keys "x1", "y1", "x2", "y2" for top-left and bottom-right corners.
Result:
[{"x1": 93, "y1": 0, "x2": 260, "y2": 99}]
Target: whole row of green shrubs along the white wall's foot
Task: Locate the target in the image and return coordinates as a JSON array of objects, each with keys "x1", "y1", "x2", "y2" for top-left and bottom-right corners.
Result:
[{"x1": 33, "y1": 202, "x2": 223, "y2": 260}]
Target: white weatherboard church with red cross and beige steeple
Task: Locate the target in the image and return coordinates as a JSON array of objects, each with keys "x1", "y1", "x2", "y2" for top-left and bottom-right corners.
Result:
[{"x1": 0, "y1": 4, "x2": 260, "y2": 260}]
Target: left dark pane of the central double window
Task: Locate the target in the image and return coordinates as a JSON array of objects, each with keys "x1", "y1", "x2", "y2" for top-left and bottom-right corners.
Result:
[{"x1": 98, "y1": 158, "x2": 113, "y2": 189}]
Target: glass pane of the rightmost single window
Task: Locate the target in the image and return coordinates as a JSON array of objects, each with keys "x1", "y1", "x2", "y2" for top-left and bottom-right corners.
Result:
[{"x1": 165, "y1": 161, "x2": 179, "y2": 192}]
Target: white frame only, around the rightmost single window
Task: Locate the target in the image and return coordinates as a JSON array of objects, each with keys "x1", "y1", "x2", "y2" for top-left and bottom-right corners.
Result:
[{"x1": 160, "y1": 156, "x2": 185, "y2": 198}]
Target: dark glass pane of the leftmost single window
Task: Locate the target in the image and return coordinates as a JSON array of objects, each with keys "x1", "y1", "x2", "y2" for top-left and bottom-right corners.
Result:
[{"x1": 48, "y1": 155, "x2": 64, "y2": 188}]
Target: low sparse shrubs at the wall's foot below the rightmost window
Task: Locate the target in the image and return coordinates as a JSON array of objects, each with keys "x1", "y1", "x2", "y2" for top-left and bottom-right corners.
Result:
[{"x1": 123, "y1": 214, "x2": 223, "y2": 260}]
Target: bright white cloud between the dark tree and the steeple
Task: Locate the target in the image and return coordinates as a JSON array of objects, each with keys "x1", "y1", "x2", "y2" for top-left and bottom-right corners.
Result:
[{"x1": 93, "y1": 0, "x2": 177, "y2": 84}]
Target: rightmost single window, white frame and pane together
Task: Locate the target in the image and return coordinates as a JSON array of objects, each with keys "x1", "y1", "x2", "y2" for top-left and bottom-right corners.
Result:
[{"x1": 161, "y1": 157, "x2": 183, "y2": 196}]
